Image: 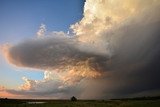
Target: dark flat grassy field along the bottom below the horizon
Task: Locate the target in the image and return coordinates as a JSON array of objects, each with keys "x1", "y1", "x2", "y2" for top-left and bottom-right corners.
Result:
[{"x1": 0, "y1": 100, "x2": 160, "y2": 107}]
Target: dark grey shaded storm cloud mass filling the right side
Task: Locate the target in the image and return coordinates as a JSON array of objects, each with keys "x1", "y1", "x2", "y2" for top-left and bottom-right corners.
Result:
[{"x1": 79, "y1": 10, "x2": 160, "y2": 98}]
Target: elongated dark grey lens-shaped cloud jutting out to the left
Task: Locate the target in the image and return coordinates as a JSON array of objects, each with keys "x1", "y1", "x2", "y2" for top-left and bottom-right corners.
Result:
[{"x1": 9, "y1": 35, "x2": 107, "y2": 70}]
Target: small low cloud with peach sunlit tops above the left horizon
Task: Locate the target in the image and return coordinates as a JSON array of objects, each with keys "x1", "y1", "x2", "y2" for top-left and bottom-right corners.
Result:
[{"x1": 7, "y1": 71, "x2": 78, "y2": 98}]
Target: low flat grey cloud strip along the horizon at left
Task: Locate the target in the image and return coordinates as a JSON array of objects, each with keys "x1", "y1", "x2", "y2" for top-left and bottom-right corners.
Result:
[{"x1": 5, "y1": 83, "x2": 81, "y2": 99}]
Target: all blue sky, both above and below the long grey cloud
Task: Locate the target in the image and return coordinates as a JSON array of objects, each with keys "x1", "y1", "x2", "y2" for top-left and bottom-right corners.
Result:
[{"x1": 0, "y1": 0, "x2": 84, "y2": 88}]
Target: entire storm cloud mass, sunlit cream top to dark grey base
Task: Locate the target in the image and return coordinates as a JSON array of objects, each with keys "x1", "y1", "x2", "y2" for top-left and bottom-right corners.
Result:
[{"x1": 2, "y1": 0, "x2": 160, "y2": 99}]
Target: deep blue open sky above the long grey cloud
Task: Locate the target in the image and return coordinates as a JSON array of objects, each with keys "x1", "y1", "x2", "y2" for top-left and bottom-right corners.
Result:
[{"x1": 0, "y1": 0, "x2": 84, "y2": 43}]
